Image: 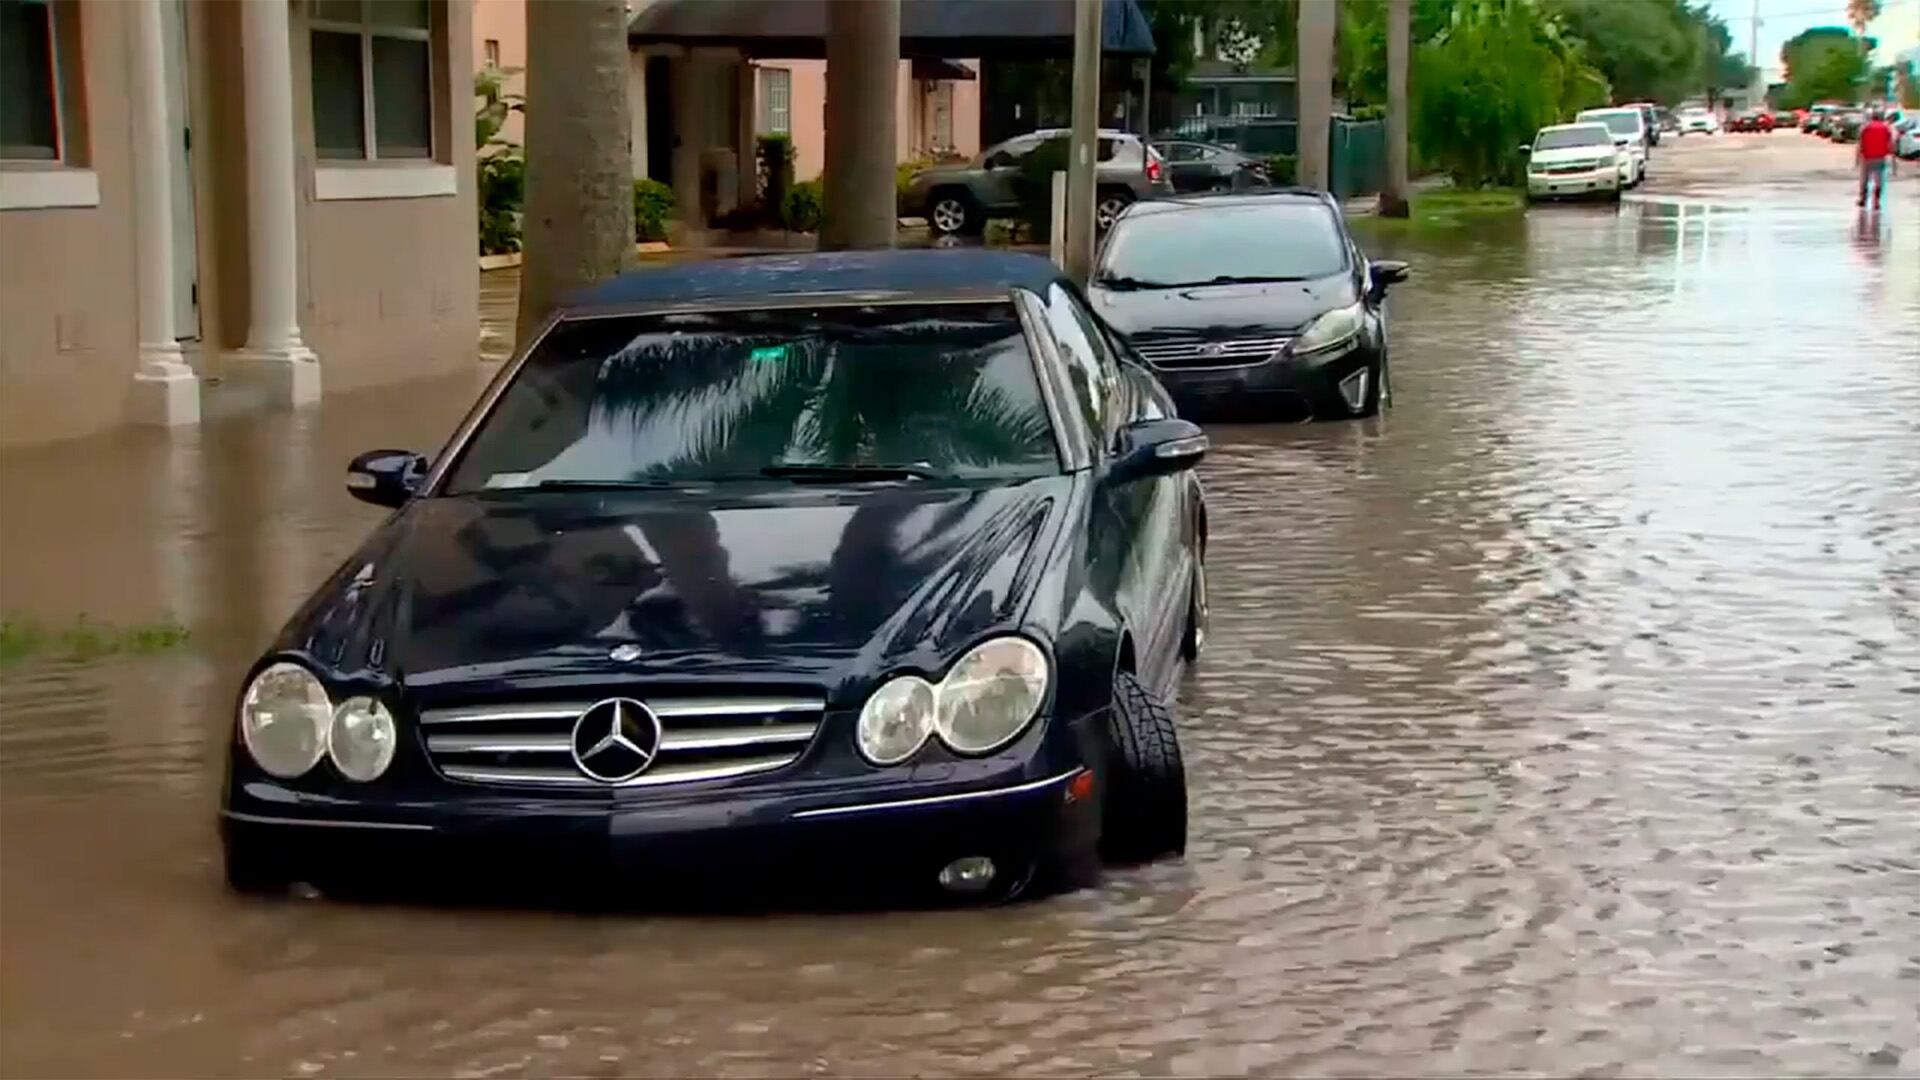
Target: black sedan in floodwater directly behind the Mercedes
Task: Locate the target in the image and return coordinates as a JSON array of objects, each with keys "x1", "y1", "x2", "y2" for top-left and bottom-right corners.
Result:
[{"x1": 1092, "y1": 190, "x2": 1407, "y2": 419}]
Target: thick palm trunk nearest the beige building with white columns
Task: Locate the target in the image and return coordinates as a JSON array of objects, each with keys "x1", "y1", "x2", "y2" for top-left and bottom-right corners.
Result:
[{"x1": 516, "y1": 0, "x2": 634, "y2": 348}]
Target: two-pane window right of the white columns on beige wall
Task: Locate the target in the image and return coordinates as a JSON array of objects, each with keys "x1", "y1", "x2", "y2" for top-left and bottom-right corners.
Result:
[{"x1": 311, "y1": 0, "x2": 434, "y2": 161}]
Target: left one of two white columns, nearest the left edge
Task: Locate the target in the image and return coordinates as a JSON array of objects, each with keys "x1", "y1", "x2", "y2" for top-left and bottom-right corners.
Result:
[{"x1": 129, "y1": 0, "x2": 200, "y2": 425}]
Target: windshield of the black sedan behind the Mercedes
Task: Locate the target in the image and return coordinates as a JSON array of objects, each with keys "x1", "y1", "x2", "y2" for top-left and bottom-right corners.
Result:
[{"x1": 1098, "y1": 200, "x2": 1346, "y2": 288}]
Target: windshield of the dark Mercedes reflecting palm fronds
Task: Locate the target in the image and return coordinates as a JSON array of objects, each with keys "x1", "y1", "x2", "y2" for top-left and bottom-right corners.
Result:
[{"x1": 444, "y1": 302, "x2": 1060, "y2": 494}]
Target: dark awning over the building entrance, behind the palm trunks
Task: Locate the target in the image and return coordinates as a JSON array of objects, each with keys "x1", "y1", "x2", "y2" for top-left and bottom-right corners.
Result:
[{"x1": 626, "y1": 0, "x2": 1154, "y2": 60}]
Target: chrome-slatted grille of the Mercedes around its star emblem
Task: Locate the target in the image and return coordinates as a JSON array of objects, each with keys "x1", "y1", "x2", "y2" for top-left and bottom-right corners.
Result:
[{"x1": 420, "y1": 698, "x2": 826, "y2": 788}]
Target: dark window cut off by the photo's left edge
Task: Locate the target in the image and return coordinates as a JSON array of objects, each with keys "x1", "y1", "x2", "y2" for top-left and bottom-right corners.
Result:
[{"x1": 0, "y1": 0, "x2": 84, "y2": 165}]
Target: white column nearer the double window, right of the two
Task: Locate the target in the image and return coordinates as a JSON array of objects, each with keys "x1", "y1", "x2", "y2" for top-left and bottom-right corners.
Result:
[{"x1": 230, "y1": 0, "x2": 321, "y2": 405}]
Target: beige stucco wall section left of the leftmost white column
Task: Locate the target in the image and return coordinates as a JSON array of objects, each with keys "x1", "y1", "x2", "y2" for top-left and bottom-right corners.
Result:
[{"x1": 0, "y1": 4, "x2": 136, "y2": 446}]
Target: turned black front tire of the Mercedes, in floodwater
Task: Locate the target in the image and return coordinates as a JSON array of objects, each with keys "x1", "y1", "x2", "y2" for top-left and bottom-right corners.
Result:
[{"x1": 1100, "y1": 671, "x2": 1187, "y2": 863}]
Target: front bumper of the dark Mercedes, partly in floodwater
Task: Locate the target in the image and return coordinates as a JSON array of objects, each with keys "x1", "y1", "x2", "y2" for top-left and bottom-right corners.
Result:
[{"x1": 221, "y1": 734, "x2": 1100, "y2": 903}]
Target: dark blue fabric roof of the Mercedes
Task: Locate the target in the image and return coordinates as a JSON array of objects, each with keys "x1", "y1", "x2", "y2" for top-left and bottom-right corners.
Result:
[{"x1": 561, "y1": 248, "x2": 1064, "y2": 313}]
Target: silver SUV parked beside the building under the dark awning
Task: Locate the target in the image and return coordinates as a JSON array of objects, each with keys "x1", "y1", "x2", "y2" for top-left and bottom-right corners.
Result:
[{"x1": 900, "y1": 127, "x2": 1173, "y2": 234}]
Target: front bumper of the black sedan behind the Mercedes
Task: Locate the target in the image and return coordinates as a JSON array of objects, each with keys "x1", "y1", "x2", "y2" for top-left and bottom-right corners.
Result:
[{"x1": 1152, "y1": 342, "x2": 1380, "y2": 421}]
